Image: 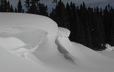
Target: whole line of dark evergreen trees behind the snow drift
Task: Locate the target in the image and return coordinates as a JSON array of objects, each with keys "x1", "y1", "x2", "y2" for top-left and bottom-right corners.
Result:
[{"x1": 0, "y1": 0, "x2": 114, "y2": 50}]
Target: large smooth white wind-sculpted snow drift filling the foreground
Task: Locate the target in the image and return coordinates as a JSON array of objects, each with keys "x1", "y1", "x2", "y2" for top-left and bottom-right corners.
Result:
[{"x1": 0, "y1": 13, "x2": 114, "y2": 72}]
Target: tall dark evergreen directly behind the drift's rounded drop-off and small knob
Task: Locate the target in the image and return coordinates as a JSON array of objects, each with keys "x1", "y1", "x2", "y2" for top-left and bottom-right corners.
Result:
[{"x1": 50, "y1": 0, "x2": 67, "y2": 27}]
